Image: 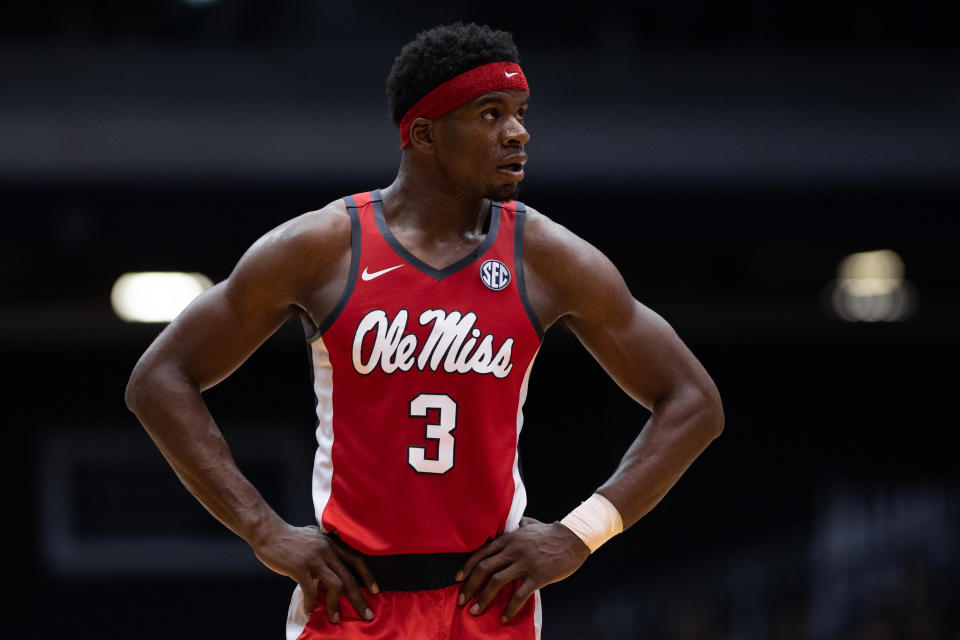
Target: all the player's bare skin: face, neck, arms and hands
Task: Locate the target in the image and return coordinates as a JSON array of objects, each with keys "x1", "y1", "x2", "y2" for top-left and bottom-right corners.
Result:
[{"x1": 126, "y1": 85, "x2": 723, "y2": 623}]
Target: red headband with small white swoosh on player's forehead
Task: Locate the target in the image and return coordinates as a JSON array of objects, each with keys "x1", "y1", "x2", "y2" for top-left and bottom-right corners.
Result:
[{"x1": 400, "y1": 62, "x2": 529, "y2": 148}]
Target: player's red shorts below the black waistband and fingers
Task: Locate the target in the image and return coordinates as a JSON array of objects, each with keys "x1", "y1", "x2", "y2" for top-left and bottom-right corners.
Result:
[{"x1": 287, "y1": 583, "x2": 540, "y2": 640}]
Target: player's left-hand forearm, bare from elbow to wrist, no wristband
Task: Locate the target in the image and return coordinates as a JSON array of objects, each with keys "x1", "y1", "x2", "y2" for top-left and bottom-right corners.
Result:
[{"x1": 126, "y1": 370, "x2": 280, "y2": 545}]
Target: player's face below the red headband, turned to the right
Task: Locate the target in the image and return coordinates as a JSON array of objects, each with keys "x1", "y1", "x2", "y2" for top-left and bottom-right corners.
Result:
[{"x1": 436, "y1": 89, "x2": 530, "y2": 200}]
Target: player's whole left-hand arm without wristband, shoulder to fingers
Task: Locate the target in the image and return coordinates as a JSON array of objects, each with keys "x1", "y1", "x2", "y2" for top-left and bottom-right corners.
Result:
[{"x1": 126, "y1": 205, "x2": 372, "y2": 615}]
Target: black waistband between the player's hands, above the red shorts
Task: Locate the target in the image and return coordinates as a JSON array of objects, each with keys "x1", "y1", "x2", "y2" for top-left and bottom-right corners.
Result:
[{"x1": 340, "y1": 542, "x2": 470, "y2": 591}]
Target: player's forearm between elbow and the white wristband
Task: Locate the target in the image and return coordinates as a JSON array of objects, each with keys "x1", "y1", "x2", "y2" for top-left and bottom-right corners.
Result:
[{"x1": 597, "y1": 389, "x2": 723, "y2": 529}]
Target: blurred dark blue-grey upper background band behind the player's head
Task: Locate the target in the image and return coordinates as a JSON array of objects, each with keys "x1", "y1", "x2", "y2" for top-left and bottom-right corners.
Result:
[{"x1": 0, "y1": 0, "x2": 960, "y2": 186}]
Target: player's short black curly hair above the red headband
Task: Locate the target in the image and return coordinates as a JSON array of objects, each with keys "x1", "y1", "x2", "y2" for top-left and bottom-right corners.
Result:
[{"x1": 387, "y1": 22, "x2": 520, "y2": 126}]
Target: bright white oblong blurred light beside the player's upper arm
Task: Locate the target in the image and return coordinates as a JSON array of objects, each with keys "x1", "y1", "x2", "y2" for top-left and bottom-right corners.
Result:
[{"x1": 110, "y1": 271, "x2": 213, "y2": 322}]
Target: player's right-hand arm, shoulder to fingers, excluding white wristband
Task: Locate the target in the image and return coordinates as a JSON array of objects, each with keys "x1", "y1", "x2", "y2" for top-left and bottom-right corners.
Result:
[{"x1": 461, "y1": 212, "x2": 723, "y2": 621}]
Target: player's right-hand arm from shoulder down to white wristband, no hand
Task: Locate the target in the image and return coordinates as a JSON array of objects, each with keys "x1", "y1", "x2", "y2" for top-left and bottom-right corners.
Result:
[{"x1": 527, "y1": 216, "x2": 723, "y2": 528}]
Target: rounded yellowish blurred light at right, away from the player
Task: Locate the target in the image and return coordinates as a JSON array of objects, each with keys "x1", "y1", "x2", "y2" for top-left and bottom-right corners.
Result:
[{"x1": 829, "y1": 249, "x2": 917, "y2": 322}]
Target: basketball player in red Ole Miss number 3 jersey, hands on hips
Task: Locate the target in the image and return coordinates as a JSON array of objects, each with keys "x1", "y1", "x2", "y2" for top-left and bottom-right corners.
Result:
[{"x1": 126, "y1": 23, "x2": 723, "y2": 640}]
